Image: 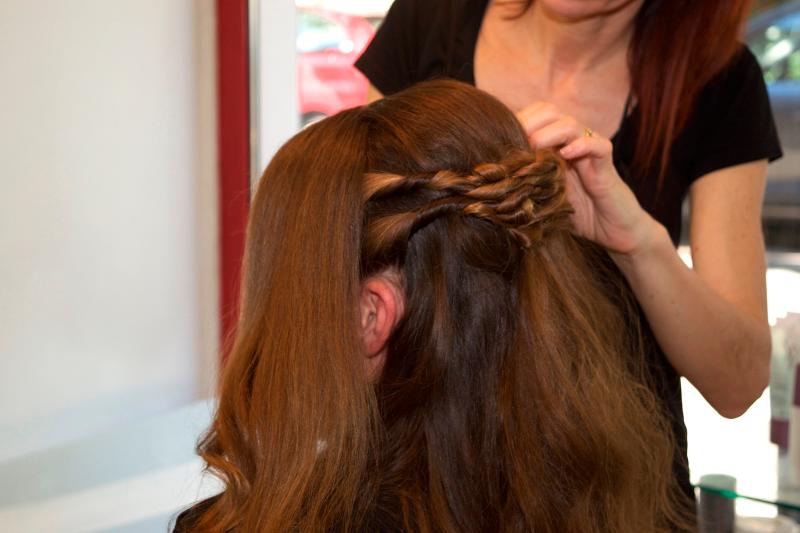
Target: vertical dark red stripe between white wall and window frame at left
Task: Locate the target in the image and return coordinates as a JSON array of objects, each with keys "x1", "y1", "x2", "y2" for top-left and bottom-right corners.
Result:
[{"x1": 216, "y1": 0, "x2": 250, "y2": 363}]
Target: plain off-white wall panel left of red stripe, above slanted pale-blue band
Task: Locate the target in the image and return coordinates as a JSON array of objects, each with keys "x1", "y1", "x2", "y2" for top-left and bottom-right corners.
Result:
[{"x1": 0, "y1": 0, "x2": 217, "y2": 460}]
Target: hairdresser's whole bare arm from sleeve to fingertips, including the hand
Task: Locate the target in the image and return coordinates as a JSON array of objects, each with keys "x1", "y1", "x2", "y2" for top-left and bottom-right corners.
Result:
[{"x1": 518, "y1": 103, "x2": 770, "y2": 418}]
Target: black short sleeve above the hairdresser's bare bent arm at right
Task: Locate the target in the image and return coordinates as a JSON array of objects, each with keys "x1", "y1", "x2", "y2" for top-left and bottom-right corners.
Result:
[{"x1": 687, "y1": 46, "x2": 783, "y2": 182}]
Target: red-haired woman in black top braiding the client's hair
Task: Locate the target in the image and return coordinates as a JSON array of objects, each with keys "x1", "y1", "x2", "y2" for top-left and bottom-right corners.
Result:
[{"x1": 356, "y1": 0, "x2": 781, "y2": 508}]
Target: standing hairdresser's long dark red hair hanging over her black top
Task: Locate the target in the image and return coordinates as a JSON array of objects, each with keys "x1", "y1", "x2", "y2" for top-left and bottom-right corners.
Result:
[{"x1": 523, "y1": 0, "x2": 752, "y2": 187}]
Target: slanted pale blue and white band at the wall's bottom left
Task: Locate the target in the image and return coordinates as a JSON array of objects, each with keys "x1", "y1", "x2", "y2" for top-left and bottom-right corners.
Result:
[{"x1": 0, "y1": 401, "x2": 222, "y2": 533}]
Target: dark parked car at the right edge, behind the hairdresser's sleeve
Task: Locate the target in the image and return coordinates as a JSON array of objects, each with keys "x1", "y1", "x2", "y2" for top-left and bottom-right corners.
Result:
[{"x1": 747, "y1": 0, "x2": 800, "y2": 251}]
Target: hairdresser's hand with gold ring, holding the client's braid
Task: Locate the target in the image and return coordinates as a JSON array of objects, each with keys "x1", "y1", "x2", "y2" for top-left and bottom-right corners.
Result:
[{"x1": 517, "y1": 102, "x2": 664, "y2": 256}]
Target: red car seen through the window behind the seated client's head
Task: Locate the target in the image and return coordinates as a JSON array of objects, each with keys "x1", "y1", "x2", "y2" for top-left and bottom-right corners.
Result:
[{"x1": 297, "y1": 8, "x2": 379, "y2": 126}]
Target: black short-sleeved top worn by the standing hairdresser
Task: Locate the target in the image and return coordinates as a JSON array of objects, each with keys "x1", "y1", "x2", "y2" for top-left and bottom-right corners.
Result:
[{"x1": 356, "y1": 0, "x2": 782, "y2": 512}]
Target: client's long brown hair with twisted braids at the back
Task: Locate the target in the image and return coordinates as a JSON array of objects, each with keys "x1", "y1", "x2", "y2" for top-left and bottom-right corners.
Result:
[{"x1": 178, "y1": 81, "x2": 683, "y2": 533}]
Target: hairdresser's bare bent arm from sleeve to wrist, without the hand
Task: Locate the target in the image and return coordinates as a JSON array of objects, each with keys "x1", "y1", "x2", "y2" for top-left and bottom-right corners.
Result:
[{"x1": 611, "y1": 161, "x2": 770, "y2": 418}]
